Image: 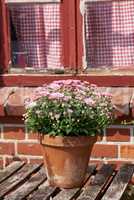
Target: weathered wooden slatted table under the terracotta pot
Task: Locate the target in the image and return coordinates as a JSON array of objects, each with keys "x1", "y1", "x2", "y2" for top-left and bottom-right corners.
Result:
[{"x1": 0, "y1": 162, "x2": 134, "y2": 200}]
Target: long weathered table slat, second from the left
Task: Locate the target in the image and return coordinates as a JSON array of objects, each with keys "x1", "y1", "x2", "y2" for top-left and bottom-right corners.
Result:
[{"x1": 0, "y1": 164, "x2": 41, "y2": 198}]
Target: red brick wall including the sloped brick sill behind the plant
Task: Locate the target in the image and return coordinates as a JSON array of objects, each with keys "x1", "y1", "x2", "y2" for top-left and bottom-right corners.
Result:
[{"x1": 0, "y1": 87, "x2": 134, "y2": 168}]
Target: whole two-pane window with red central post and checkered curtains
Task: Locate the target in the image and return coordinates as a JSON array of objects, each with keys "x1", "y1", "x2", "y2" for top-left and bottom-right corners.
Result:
[{"x1": 1, "y1": 0, "x2": 134, "y2": 75}]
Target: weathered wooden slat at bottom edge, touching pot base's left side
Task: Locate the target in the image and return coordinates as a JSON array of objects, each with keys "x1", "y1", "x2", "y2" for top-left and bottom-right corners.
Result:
[{"x1": 27, "y1": 184, "x2": 59, "y2": 200}]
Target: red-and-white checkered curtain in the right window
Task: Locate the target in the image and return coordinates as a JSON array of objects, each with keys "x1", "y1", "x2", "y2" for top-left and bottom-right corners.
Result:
[{"x1": 85, "y1": 0, "x2": 134, "y2": 68}]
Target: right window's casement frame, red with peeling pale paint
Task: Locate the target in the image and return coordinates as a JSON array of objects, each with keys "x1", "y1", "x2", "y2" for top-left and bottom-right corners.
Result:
[{"x1": 77, "y1": 0, "x2": 134, "y2": 76}]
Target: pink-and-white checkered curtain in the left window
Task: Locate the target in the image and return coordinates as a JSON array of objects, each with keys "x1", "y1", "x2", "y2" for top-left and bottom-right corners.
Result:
[{"x1": 10, "y1": 3, "x2": 62, "y2": 68}]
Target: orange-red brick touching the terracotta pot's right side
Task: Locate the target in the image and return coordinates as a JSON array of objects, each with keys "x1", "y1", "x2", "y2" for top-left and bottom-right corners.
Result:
[{"x1": 91, "y1": 144, "x2": 118, "y2": 158}]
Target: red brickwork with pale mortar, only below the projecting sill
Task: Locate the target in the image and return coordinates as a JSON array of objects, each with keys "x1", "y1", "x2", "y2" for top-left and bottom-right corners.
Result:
[{"x1": 0, "y1": 123, "x2": 134, "y2": 168}]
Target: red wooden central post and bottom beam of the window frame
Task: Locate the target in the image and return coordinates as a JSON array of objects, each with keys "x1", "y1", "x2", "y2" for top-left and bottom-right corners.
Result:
[{"x1": 0, "y1": 0, "x2": 134, "y2": 87}]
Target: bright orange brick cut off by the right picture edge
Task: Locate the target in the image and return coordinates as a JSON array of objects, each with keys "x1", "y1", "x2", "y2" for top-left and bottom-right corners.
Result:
[{"x1": 120, "y1": 145, "x2": 134, "y2": 159}]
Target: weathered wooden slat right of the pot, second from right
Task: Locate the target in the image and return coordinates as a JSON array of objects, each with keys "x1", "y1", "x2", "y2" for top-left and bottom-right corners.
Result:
[{"x1": 78, "y1": 164, "x2": 115, "y2": 200}]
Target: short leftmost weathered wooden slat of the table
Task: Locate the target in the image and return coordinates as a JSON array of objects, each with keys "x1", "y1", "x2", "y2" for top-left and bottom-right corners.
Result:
[{"x1": 0, "y1": 161, "x2": 25, "y2": 183}]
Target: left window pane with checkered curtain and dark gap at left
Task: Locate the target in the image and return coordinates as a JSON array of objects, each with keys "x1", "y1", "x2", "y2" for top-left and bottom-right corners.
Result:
[{"x1": 7, "y1": 0, "x2": 63, "y2": 70}]
